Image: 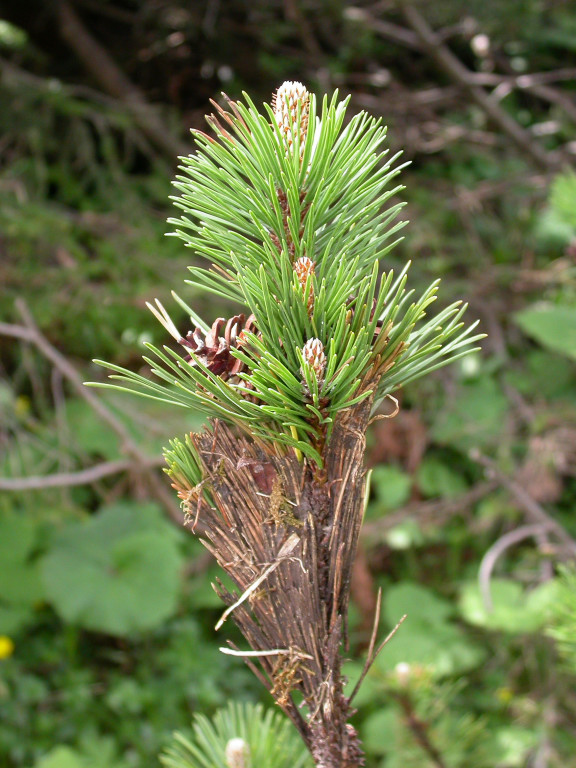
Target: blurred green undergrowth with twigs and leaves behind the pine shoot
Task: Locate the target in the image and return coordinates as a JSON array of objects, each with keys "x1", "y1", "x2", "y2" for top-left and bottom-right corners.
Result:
[{"x1": 0, "y1": 0, "x2": 576, "y2": 768}]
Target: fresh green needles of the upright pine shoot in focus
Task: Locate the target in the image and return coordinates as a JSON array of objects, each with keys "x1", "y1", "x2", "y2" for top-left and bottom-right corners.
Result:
[{"x1": 94, "y1": 85, "x2": 482, "y2": 468}]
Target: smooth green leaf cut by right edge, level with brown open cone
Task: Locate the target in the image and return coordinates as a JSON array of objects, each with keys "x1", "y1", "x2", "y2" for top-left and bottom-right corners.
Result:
[{"x1": 514, "y1": 302, "x2": 576, "y2": 360}]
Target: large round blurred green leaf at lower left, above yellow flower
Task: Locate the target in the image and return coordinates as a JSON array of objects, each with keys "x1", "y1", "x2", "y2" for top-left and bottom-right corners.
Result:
[{"x1": 42, "y1": 504, "x2": 182, "y2": 636}]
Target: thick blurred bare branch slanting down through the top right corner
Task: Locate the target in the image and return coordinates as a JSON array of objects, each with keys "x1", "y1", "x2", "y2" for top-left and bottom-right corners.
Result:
[{"x1": 400, "y1": 0, "x2": 562, "y2": 170}]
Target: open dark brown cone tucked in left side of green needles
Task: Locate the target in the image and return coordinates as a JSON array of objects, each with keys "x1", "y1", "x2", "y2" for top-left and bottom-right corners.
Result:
[{"x1": 180, "y1": 315, "x2": 256, "y2": 379}]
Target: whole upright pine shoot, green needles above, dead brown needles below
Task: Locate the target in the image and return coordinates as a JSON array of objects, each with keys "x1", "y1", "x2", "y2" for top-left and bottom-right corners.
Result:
[{"x1": 91, "y1": 83, "x2": 481, "y2": 768}]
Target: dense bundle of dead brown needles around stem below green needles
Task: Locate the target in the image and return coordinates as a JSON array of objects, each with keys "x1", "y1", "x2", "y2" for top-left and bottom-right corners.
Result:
[{"x1": 173, "y1": 398, "x2": 371, "y2": 768}]
